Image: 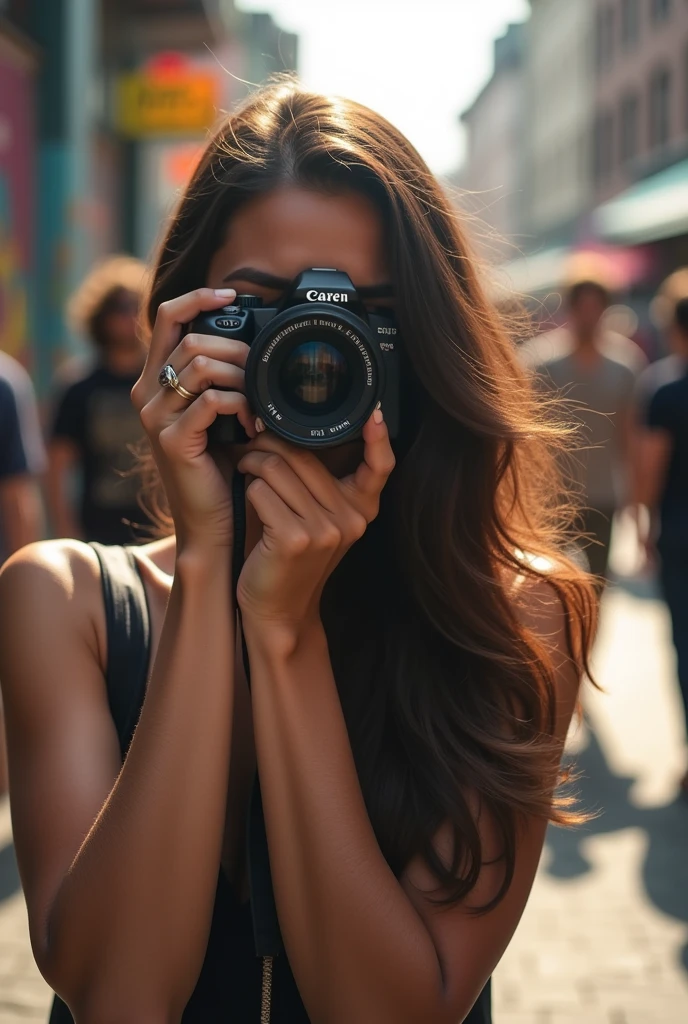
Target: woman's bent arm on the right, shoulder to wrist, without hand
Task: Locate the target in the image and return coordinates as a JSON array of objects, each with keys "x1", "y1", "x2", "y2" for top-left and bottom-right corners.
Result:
[{"x1": 247, "y1": 585, "x2": 577, "y2": 1024}]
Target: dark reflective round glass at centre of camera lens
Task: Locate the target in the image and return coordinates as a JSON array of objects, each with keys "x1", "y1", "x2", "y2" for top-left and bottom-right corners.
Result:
[{"x1": 280, "y1": 341, "x2": 351, "y2": 415}]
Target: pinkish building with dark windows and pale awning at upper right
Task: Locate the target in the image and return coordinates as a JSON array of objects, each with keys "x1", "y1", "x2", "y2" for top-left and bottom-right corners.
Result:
[{"x1": 592, "y1": 0, "x2": 688, "y2": 275}]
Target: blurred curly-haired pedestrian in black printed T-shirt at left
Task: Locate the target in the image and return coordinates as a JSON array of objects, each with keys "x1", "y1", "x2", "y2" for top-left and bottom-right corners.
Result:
[{"x1": 48, "y1": 256, "x2": 147, "y2": 544}]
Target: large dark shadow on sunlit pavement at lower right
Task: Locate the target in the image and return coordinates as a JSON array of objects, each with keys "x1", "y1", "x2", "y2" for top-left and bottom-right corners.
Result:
[{"x1": 547, "y1": 724, "x2": 688, "y2": 971}]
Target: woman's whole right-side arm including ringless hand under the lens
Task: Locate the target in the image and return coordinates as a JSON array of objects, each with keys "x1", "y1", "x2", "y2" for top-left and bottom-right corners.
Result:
[{"x1": 233, "y1": 415, "x2": 578, "y2": 1024}]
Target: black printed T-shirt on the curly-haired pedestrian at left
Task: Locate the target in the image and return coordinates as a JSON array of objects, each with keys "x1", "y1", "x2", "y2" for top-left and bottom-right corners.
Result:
[{"x1": 52, "y1": 367, "x2": 148, "y2": 544}]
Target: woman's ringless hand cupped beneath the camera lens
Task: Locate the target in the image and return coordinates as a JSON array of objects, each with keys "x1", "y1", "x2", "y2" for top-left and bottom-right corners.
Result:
[{"x1": 238, "y1": 412, "x2": 394, "y2": 635}]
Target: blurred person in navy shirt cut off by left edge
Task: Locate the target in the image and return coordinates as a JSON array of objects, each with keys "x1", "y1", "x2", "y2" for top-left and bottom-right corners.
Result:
[{"x1": 0, "y1": 352, "x2": 45, "y2": 796}]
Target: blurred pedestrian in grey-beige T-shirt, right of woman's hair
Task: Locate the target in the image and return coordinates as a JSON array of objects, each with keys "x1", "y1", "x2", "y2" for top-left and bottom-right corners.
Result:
[{"x1": 521, "y1": 279, "x2": 646, "y2": 588}]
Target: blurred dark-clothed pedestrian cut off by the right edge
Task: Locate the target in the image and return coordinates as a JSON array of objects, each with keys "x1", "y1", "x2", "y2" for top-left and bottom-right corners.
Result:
[{"x1": 636, "y1": 298, "x2": 688, "y2": 796}]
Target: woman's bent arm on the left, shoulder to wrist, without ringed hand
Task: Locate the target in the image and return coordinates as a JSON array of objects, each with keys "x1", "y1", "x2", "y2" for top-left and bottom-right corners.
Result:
[{"x1": 0, "y1": 543, "x2": 234, "y2": 1024}]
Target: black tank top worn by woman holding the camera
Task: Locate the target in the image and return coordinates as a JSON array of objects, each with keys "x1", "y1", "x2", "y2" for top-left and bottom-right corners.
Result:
[{"x1": 50, "y1": 544, "x2": 491, "y2": 1024}]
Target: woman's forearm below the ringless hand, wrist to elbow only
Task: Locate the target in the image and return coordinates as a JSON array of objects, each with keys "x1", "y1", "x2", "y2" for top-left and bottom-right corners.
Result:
[{"x1": 247, "y1": 624, "x2": 443, "y2": 1024}]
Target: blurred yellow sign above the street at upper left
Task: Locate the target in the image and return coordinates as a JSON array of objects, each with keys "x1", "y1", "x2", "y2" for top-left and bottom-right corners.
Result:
[{"x1": 116, "y1": 71, "x2": 218, "y2": 138}]
